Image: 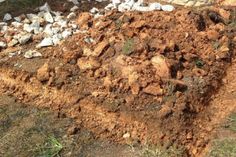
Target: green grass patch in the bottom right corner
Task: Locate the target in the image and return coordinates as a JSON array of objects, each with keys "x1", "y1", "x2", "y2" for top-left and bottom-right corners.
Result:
[{"x1": 208, "y1": 138, "x2": 236, "y2": 157}]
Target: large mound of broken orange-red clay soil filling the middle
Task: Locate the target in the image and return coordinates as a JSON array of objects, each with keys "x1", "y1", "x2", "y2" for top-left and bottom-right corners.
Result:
[{"x1": 0, "y1": 5, "x2": 235, "y2": 156}]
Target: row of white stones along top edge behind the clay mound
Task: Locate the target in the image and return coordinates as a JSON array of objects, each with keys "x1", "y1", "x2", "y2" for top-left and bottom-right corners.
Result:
[{"x1": 105, "y1": 0, "x2": 175, "y2": 12}]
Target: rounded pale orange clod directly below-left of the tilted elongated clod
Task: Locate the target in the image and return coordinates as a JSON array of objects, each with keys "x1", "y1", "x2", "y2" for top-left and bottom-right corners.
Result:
[{"x1": 77, "y1": 57, "x2": 101, "y2": 70}]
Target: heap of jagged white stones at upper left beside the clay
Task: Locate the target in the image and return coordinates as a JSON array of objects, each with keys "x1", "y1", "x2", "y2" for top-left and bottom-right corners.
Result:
[{"x1": 0, "y1": 3, "x2": 78, "y2": 48}]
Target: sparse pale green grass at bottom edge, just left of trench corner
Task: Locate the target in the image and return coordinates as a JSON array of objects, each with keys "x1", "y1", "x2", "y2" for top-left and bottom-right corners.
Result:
[{"x1": 141, "y1": 146, "x2": 184, "y2": 157}]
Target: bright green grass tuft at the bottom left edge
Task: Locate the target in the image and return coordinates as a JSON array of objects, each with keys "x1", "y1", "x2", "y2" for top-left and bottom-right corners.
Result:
[{"x1": 35, "y1": 136, "x2": 63, "y2": 157}]
